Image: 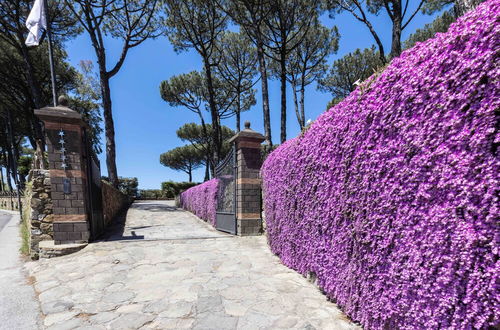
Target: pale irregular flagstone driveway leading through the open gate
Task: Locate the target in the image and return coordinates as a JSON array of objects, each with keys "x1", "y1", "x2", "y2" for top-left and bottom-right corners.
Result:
[{"x1": 28, "y1": 202, "x2": 357, "y2": 330}]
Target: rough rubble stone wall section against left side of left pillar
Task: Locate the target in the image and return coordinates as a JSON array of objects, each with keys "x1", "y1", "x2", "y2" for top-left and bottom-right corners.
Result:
[{"x1": 23, "y1": 170, "x2": 54, "y2": 259}]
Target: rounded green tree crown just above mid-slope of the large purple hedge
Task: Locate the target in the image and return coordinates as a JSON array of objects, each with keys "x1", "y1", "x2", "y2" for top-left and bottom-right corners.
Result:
[{"x1": 318, "y1": 46, "x2": 383, "y2": 104}]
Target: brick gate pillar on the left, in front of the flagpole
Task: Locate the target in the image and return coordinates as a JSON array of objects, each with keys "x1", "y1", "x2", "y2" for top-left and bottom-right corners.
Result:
[{"x1": 35, "y1": 97, "x2": 89, "y2": 245}]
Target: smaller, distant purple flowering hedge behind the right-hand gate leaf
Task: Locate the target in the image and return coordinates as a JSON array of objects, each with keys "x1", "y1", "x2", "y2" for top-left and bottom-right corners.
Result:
[{"x1": 180, "y1": 179, "x2": 219, "y2": 227}]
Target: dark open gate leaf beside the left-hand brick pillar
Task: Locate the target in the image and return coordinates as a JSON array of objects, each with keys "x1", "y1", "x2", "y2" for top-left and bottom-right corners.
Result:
[{"x1": 84, "y1": 132, "x2": 104, "y2": 240}]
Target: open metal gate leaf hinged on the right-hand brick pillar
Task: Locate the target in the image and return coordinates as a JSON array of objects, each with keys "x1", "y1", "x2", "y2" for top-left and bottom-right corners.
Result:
[{"x1": 215, "y1": 144, "x2": 237, "y2": 234}]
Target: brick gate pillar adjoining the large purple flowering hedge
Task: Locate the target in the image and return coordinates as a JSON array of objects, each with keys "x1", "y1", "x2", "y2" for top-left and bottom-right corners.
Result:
[{"x1": 230, "y1": 121, "x2": 265, "y2": 236}]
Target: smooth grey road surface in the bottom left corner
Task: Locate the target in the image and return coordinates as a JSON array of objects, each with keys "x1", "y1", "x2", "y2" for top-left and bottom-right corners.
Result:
[{"x1": 0, "y1": 210, "x2": 40, "y2": 330}]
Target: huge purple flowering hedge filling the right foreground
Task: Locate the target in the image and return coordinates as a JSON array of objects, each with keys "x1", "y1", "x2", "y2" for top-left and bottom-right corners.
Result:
[{"x1": 262, "y1": 0, "x2": 500, "y2": 329}]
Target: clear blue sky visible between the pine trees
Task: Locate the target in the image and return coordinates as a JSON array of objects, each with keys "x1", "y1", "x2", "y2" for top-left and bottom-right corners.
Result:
[{"x1": 63, "y1": 4, "x2": 446, "y2": 189}]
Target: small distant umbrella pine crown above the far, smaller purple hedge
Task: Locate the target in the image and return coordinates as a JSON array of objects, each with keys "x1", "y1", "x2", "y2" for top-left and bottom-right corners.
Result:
[{"x1": 160, "y1": 145, "x2": 206, "y2": 182}]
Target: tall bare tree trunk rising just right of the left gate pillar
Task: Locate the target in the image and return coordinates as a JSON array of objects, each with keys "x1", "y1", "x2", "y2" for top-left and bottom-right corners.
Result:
[{"x1": 98, "y1": 69, "x2": 118, "y2": 188}]
